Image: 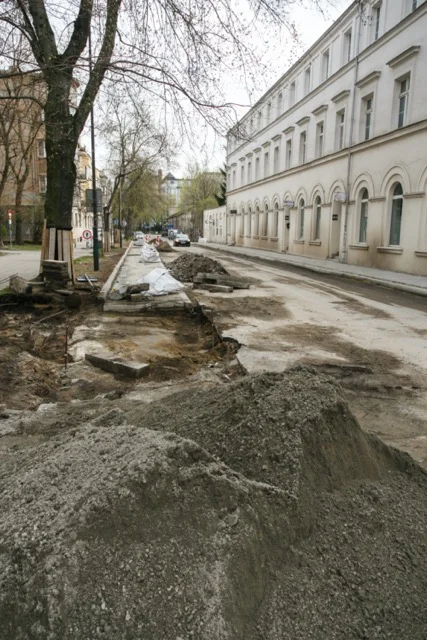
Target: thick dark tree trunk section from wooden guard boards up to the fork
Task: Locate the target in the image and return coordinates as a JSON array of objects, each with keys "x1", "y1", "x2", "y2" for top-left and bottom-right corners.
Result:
[{"x1": 45, "y1": 70, "x2": 78, "y2": 229}]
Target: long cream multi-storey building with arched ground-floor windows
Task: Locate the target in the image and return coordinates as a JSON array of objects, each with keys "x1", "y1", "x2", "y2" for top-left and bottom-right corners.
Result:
[{"x1": 227, "y1": 0, "x2": 427, "y2": 274}]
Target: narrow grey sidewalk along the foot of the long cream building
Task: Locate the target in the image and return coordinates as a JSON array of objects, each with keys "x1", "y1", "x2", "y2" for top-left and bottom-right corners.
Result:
[{"x1": 202, "y1": 242, "x2": 427, "y2": 297}]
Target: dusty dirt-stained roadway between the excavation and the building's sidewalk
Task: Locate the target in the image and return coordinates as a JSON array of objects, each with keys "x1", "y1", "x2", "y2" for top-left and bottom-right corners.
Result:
[{"x1": 182, "y1": 246, "x2": 427, "y2": 464}]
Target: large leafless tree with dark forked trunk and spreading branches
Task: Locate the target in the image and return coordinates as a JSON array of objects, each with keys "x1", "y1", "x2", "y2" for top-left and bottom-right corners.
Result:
[{"x1": 0, "y1": 0, "x2": 334, "y2": 255}]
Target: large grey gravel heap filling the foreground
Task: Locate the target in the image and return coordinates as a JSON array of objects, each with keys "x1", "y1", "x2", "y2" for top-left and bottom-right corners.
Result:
[{"x1": 0, "y1": 369, "x2": 427, "y2": 640}]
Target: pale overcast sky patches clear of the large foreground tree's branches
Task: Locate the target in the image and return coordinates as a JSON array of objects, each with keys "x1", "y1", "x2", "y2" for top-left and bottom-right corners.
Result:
[{"x1": 82, "y1": 0, "x2": 353, "y2": 177}]
